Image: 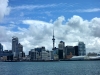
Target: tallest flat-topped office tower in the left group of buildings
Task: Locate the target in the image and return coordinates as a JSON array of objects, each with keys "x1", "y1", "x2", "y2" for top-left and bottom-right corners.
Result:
[{"x1": 12, "y1": 37, "x2": 19, "y2": 57}]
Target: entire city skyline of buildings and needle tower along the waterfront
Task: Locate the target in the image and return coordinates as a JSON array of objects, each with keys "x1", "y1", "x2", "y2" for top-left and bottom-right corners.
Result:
[{"x1": 0, "y1": 31, "x2": 86, "y2": 61}]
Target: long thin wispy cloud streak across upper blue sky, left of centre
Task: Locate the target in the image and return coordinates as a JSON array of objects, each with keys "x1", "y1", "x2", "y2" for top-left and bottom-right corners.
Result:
[{"x1": 12, "y1": 3, "x2": 77, "y2": 10}]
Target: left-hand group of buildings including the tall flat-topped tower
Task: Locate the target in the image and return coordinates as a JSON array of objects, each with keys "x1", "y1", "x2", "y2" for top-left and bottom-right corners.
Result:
[{"x1": 0, "y1": 37, "x2": 25, "y2": 61}]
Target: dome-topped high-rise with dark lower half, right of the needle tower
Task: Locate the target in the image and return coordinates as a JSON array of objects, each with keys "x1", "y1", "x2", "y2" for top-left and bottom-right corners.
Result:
[{"x1": 58, "y1": 41, "x2": 65, "y2": 59}]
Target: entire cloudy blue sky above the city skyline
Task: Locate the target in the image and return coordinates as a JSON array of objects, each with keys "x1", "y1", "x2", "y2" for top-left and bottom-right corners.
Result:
[{"x1": 0, "y1": 0, "x2": 100, "y2": 54}]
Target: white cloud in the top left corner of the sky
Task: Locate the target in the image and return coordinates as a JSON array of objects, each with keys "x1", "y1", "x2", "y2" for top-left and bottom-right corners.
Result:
[{"x1": 0, "y1": 0, "x2": 10, "y2": 21}]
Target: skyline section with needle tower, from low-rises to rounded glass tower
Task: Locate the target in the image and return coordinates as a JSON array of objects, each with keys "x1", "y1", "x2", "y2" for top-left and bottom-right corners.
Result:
[{"x1": 29, "y1": 30, "x2": 86, "y2": 61}]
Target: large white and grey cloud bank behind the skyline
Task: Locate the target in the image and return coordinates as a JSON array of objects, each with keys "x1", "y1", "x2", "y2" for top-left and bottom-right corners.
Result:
[{"x1": 0, "y1": 15, "x2": 100, "y2": 53}]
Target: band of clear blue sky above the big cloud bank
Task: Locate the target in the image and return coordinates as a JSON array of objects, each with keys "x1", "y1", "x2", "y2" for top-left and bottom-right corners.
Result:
[{"x1": 1, "y1": 0, "x2": 100, "y2": 23}]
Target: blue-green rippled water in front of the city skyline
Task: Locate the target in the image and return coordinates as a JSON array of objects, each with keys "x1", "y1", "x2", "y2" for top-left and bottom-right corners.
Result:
[{"x1": 0, "y1": 61, "x2": 100, "y2": 75}]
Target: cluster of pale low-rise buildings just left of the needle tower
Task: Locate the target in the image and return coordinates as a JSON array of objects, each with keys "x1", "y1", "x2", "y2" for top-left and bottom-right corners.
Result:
[{"x1": 29, "y1": 47, "x2": 52, "y2": 61}]
